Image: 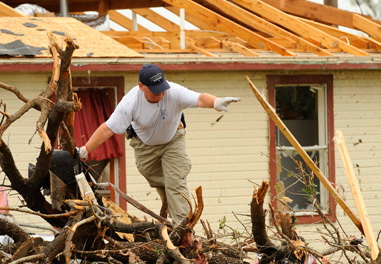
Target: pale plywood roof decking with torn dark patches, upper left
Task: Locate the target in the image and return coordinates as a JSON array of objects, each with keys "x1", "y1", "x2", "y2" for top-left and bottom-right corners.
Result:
[{"x1": 0, "y1": 17, "x2": 142, "y2": 58}]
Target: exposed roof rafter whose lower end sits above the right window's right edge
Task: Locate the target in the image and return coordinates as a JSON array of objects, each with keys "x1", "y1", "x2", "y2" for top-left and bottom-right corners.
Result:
[{"x1": 204, "y1": 0, "x2": 333, "y2": 56}]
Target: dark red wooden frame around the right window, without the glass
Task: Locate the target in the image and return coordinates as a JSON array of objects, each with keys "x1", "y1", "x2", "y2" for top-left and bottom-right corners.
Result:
[{"x1": 267, "y1": 75, "x2": 336, "y2": 224}]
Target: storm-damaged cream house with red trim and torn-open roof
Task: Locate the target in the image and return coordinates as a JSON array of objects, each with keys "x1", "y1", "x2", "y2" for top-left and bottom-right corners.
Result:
[{"x1": 0, "y1": 0, "x2": 381, "y2": 253}]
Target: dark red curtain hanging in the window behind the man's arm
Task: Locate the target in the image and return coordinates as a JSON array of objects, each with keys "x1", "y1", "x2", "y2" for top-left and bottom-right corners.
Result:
[{"x1": 74, "y1": 89, "x2": 122, "y2": 160}]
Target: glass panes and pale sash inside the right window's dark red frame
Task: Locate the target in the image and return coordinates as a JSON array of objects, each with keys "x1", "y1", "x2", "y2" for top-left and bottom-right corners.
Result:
[{"x1": 275, "y1": 85, "x2": 327, "y2": 212}]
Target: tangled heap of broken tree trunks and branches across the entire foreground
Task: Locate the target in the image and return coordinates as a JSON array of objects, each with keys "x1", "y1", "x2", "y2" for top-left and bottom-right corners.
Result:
[{"x1": 0, "y1": 34, "x2": 378, "y2": 264}]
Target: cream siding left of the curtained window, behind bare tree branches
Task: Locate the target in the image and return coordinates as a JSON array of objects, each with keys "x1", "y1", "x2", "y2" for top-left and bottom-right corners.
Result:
[{"x1": 0, "y1": 73, "x2": 56, "y2": 234}]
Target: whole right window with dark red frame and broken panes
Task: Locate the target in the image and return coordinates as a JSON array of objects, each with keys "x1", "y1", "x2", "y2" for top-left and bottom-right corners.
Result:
[{"x1": 268, "y1": 75, "x2": 335, "y2": 223}]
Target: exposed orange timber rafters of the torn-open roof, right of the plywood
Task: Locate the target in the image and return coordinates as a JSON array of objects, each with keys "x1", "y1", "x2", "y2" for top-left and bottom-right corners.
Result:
[{"x1": 102, "y1": 0, "x2": 381, "y2": 57}]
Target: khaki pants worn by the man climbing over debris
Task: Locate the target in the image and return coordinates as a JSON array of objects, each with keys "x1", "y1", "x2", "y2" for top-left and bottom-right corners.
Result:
[{"x1": 130, "y1": 129, "x2": 192, "y2": 227}]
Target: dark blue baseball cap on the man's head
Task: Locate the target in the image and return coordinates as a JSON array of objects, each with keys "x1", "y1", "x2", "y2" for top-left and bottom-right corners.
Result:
[{"x1": 139, "y1": 64, "x2": 170, "y2": 94}]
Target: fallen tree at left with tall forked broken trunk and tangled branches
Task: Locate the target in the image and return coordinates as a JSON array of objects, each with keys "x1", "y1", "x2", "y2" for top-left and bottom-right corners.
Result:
[{"x1": 0, "y1": 33, "x2": 246, "y2": 263}]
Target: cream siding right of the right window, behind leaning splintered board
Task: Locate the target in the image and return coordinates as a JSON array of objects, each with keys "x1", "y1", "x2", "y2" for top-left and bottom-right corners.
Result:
[{"x1": 334, "y1": 71, "x2": 381, "y2": 236}]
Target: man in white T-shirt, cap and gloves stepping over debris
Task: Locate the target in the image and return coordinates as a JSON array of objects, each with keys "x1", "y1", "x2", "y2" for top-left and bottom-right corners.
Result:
[{"x1": 79, "y1": 64, "x2": 240, "y2": 226}]
